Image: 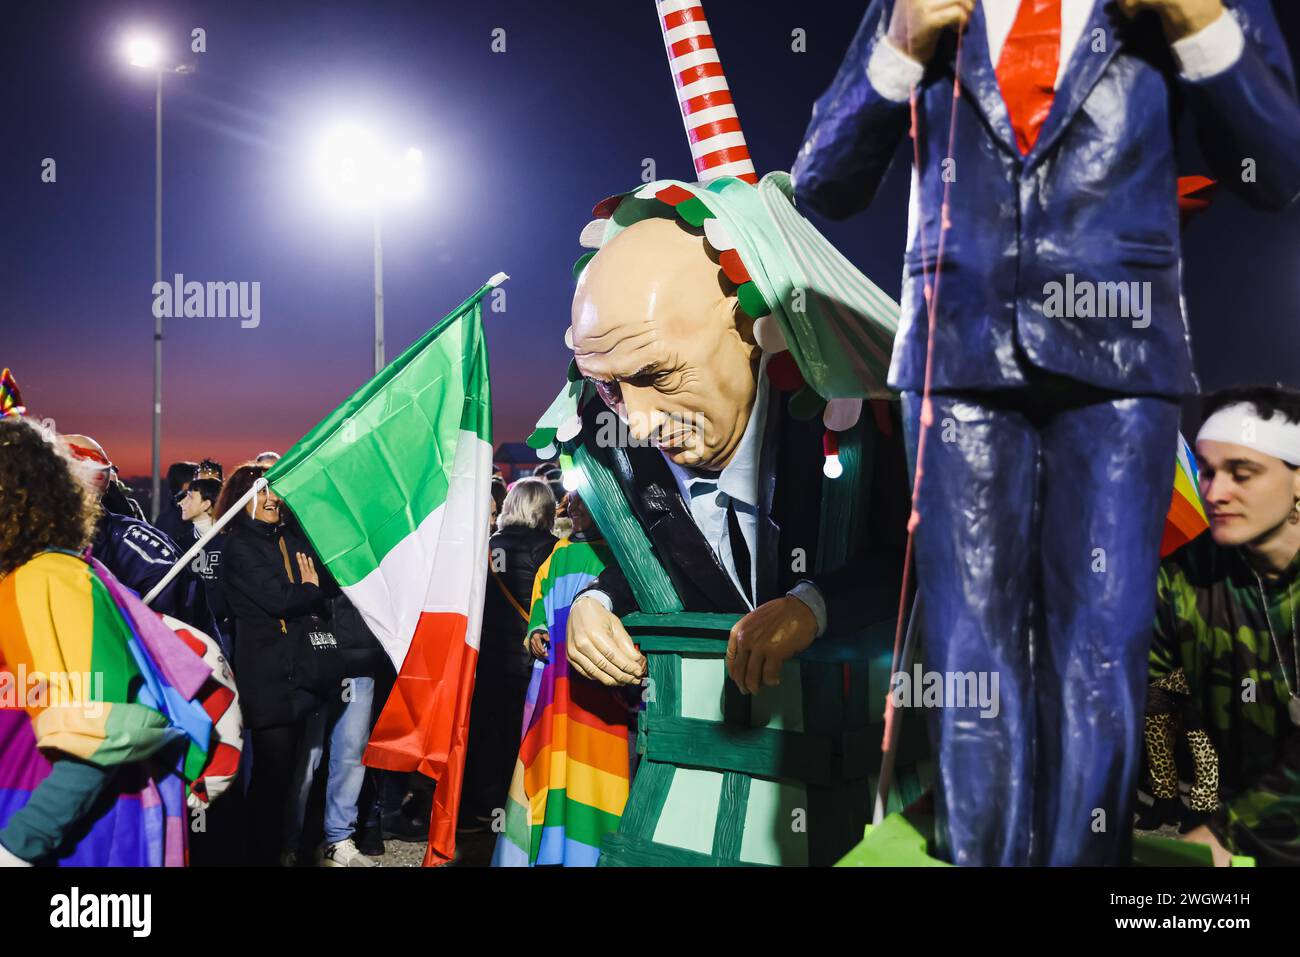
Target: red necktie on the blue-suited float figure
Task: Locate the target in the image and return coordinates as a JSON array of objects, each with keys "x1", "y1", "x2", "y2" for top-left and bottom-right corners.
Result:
[{"x1": 997, "y1": 0, "x2": 1061, "y2": 153}]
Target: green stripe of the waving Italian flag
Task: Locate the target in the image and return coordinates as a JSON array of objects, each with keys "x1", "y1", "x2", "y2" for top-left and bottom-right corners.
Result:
[{"x1": 267, "y1": 285, "x2": 493, "y2": 586}]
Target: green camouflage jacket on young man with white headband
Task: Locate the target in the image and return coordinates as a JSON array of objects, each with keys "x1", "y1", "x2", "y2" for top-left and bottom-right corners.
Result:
[{"x1": 1151, "y1": 534, "x2": 1300, "y2": 865}]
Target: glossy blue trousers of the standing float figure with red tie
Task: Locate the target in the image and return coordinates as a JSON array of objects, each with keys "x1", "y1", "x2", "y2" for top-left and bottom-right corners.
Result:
[{"x1": 904, "y1": 380, "x2": 1179, "y2": 865}]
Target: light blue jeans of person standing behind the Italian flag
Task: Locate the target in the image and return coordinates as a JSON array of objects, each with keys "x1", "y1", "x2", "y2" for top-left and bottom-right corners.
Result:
[{"x1": 293, "y1": 677, "x2": 374, "y2": 845}]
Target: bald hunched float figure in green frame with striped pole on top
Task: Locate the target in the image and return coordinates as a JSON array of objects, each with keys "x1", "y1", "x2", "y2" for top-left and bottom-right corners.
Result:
[{"x1": 530, "y1": 0, "x2": 923, "y2": 865}]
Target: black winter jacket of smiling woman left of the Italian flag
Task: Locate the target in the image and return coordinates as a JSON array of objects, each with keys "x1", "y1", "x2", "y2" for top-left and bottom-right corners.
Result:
[{"x1": 221, "y1": 514, "x2": 338, "y2": 729}]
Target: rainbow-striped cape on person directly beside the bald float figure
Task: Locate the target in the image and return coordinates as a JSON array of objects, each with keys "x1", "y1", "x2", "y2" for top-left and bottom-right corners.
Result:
[{"x1": 493, "y1": 538, "x2": 640, "y2": 867}]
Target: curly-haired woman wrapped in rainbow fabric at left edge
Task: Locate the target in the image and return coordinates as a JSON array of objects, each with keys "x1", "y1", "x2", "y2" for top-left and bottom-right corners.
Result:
[{"x1": 0, "y1": 417, "x2": 212, "y2": 866}]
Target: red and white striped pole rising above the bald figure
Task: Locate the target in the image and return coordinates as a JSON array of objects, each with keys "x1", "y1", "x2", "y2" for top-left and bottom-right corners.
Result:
[{"x1": 657, "y1": 0, "x2": 758, "y2": 183}]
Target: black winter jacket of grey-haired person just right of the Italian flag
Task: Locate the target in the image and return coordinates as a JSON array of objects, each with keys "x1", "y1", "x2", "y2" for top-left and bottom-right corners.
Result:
[{"x1": 478, "y1": 525, "x2": 558, "y2": 680}]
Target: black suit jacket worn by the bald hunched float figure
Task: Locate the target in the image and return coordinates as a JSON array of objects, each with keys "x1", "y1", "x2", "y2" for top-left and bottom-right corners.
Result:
[{"x1": 582, "y1": 387, "x2": 909, "y2": 631}]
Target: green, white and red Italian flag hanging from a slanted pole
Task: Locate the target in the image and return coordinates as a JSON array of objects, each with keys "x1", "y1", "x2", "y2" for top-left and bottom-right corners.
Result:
[{"x1": 267, "y1": 273, "x2": 506, "y2": 866}]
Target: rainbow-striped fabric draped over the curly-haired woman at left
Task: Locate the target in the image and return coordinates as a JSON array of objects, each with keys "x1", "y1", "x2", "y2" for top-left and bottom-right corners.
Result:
[{"x1": 0, "y1": 551, "x2": 212, "y2": 867}]
